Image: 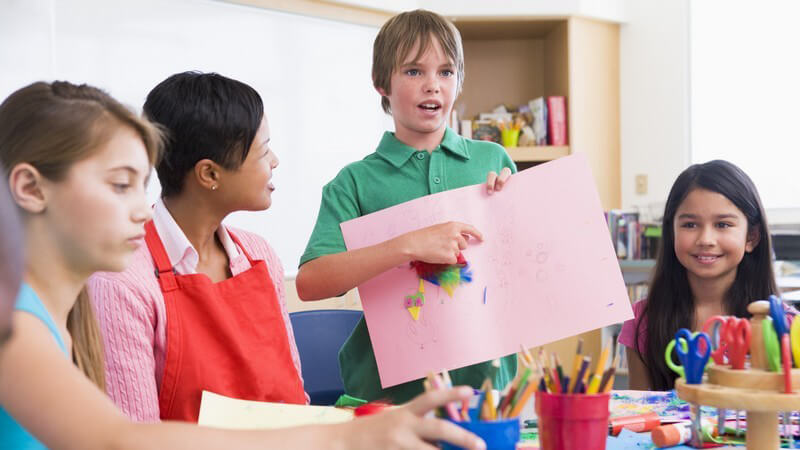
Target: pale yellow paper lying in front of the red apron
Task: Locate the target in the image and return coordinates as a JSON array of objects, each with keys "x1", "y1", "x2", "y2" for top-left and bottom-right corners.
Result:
[{"x1": 197, "y1": 391, "x2": 353, "y2": 429}]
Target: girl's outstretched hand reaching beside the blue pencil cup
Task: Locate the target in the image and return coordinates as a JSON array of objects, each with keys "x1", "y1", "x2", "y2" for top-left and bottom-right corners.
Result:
[{"x1": 341, "y1": 386, "x2": 486, "y2": 450}]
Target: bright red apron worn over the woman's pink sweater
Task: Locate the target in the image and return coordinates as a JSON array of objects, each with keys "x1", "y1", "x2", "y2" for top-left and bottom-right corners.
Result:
[{"x1": 145, "y1": 220, "x2": 306, "y2": 422}]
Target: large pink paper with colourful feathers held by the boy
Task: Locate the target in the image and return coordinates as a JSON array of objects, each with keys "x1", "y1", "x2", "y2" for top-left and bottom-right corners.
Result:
[{"x1": 341, "y1": 154, "x2": 633, "y2": 388}]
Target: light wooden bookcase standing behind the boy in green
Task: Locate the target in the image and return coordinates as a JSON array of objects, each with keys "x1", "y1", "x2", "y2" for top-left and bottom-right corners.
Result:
[{"x1": 451, "y1": 16, "x2": 621, "y2": 361}]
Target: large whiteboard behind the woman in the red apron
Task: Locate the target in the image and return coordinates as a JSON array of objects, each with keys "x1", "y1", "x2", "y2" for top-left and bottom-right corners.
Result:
[{"x1": 0, "y1": 0, "x2": 392, "y2": 277}]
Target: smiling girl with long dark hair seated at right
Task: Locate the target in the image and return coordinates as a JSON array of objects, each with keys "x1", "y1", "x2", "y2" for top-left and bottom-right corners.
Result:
[{"x1": 619, "y1": 160, "x2": 796, "y2": 390}]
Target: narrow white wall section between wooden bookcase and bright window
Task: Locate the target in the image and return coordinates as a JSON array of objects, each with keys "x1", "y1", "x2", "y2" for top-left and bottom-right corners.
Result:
[{"x1": 620, "y1": 0, "x2": 690, "y2": 216}]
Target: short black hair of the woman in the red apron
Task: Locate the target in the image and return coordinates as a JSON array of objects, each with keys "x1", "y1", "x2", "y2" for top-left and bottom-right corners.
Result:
[{"x1": 144, "y1": 72, "x2": 264, "y2": 197}]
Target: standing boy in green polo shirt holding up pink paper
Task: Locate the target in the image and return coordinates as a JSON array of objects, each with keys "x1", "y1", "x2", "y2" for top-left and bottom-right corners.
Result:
[{"x1": 297, "y1": 10, "x2": 516, "y2": 403}]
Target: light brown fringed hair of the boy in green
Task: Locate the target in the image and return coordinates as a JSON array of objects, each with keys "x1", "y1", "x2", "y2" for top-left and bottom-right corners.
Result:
[{"x1": 372, "y1": 9, "x2": 464, "y2": 113}]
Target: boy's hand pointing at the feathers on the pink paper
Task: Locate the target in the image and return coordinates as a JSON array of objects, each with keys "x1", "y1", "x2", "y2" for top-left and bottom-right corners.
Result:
[{"x1": 396, "y1": 222, "x2": 483, "y2": 264}]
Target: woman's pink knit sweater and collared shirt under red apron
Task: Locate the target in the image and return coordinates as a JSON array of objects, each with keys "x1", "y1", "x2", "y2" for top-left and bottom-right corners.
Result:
[{"x1": 87, "y1": 200, "x2": 308, "y2": 422}]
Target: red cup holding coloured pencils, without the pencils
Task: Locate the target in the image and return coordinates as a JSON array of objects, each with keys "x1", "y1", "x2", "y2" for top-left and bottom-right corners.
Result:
[{"x1": 536, "y1": 392, "x2": 609, "y2": 450}]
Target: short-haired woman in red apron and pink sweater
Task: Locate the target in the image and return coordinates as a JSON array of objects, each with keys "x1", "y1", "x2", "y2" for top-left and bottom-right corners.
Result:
[{"x1": 88, "y1": 73, "x2": 307, "y2": 422}]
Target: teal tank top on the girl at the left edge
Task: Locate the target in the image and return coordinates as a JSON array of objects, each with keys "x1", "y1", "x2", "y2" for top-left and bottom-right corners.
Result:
[{"x1": 0, "y1": 283, "x2": 69, "y2": 450}]
